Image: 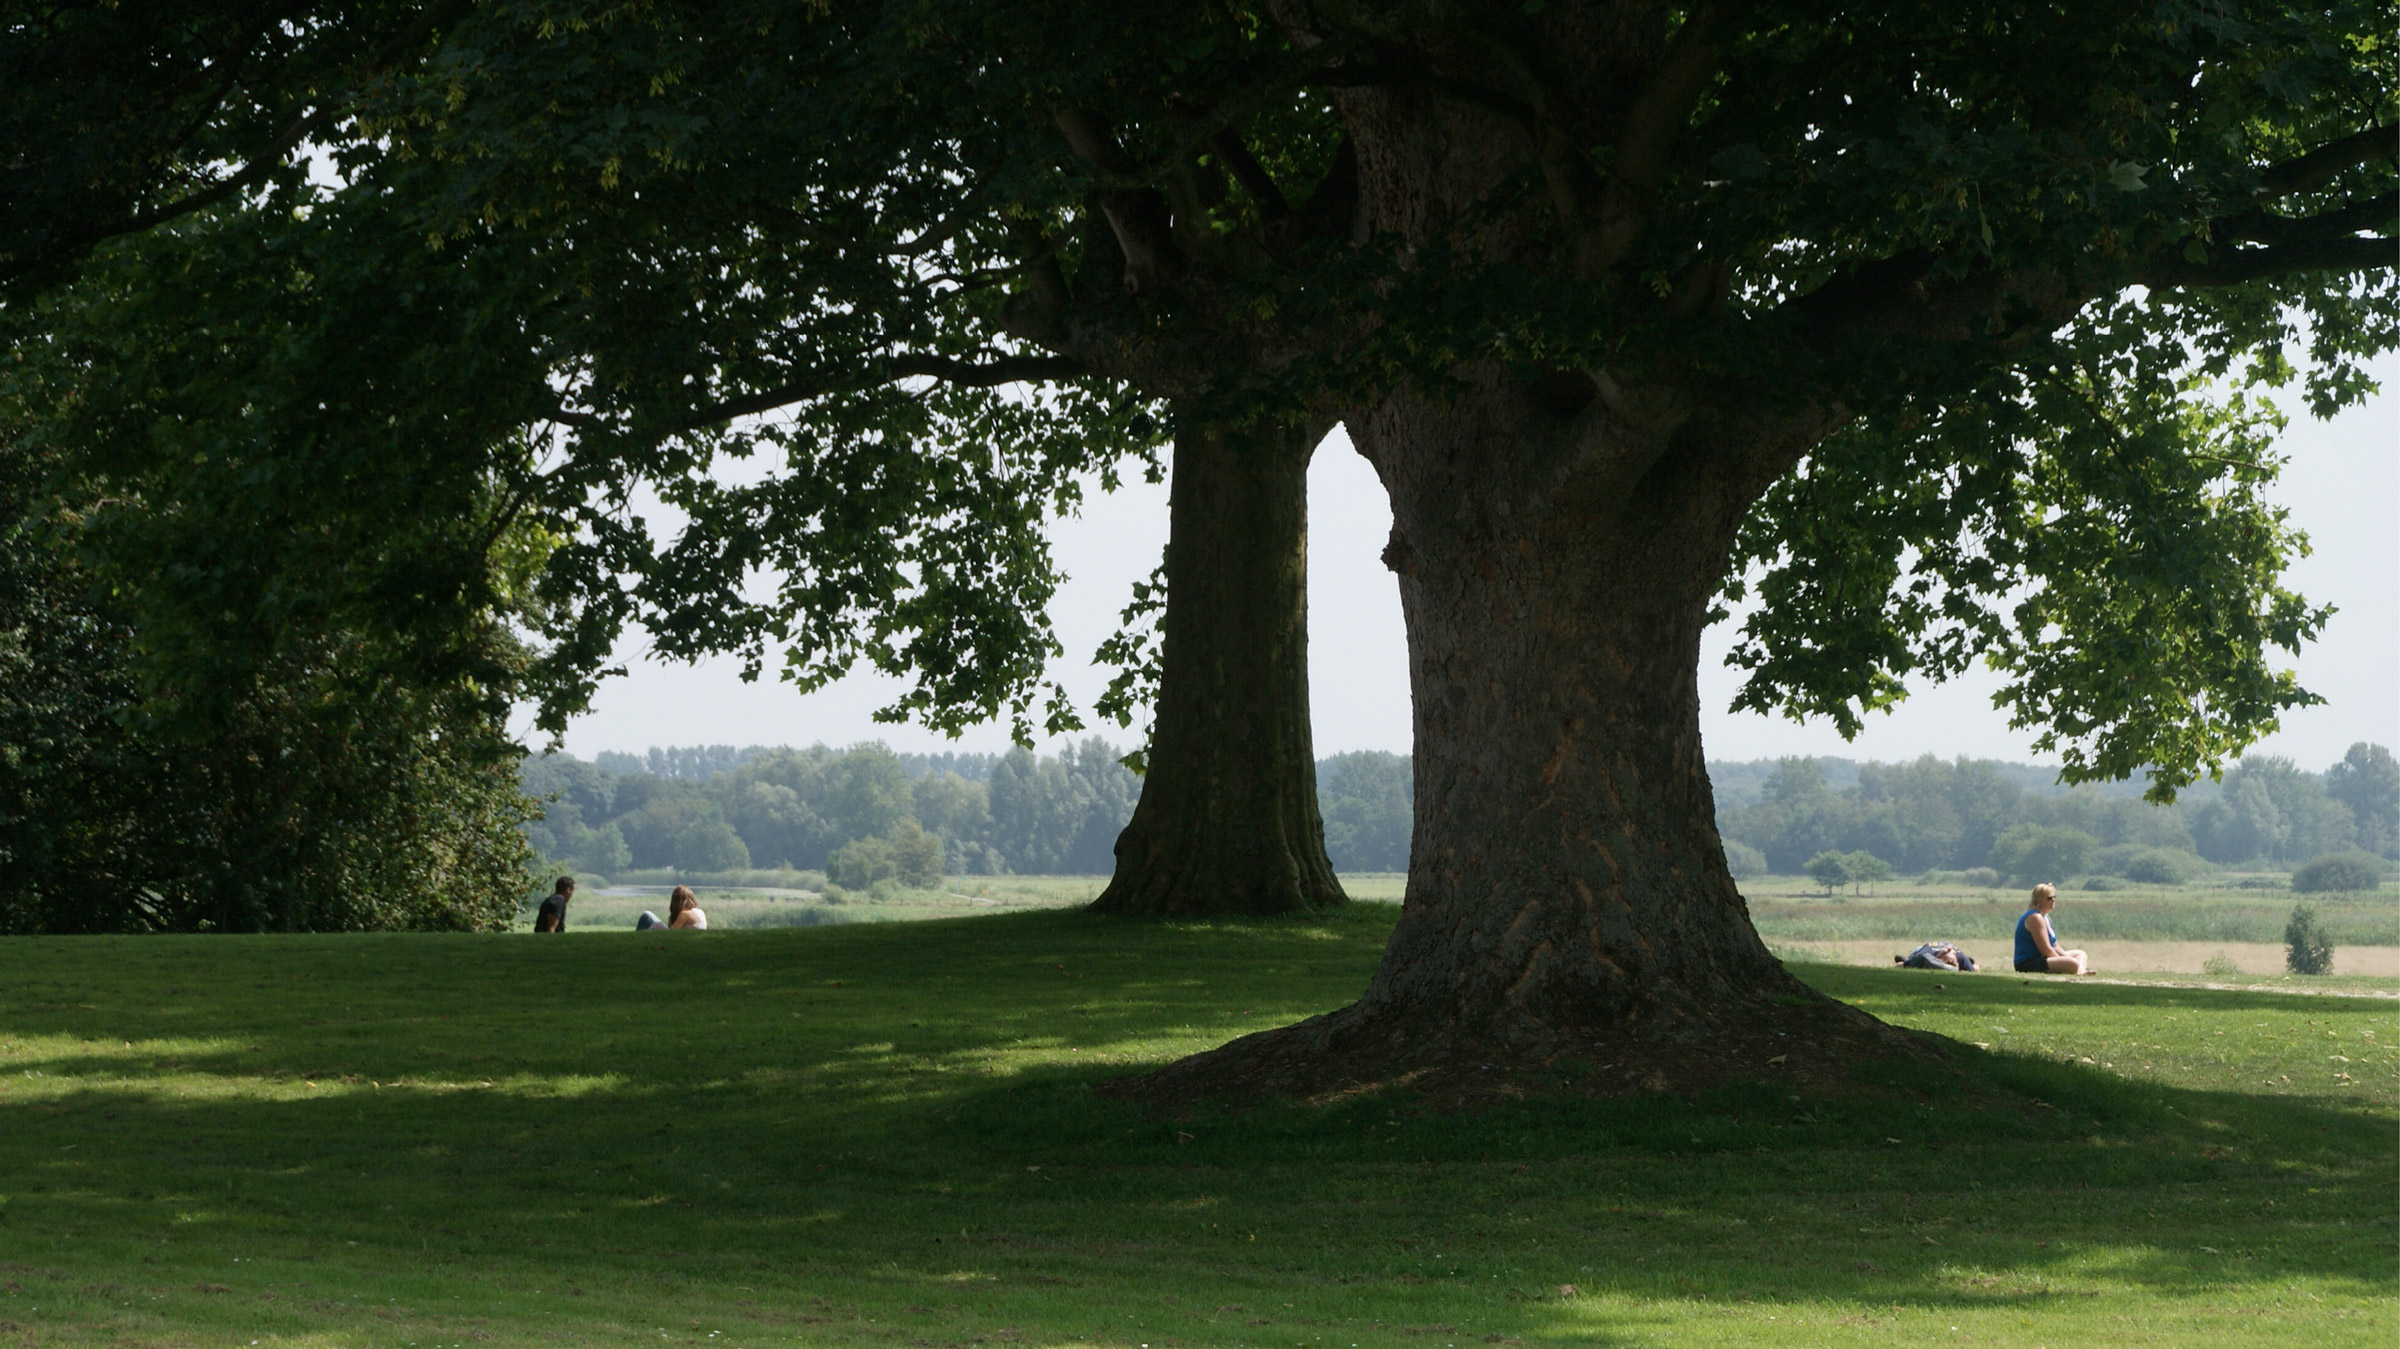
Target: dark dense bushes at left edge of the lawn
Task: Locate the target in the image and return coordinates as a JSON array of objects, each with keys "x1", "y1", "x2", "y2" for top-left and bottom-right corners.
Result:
[{"x1": 0, "y1": 446, "x2": 533, "y2": 931}]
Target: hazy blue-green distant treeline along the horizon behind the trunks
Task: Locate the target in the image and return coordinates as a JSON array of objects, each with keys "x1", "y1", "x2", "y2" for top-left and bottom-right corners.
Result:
[{"x1": 523, "y1": 737, "x2": 2400, "y2": 883}]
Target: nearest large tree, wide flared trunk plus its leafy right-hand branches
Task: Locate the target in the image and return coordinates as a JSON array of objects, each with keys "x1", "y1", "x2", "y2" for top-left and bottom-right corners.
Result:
[{"x1": 1178, "y1": 2, "x2": 2395, "y2": 1090}]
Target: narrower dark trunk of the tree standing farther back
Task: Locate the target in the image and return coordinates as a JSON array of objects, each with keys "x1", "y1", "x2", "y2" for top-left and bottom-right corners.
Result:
[{"x1": 1092, "y1": 418, "x2": 1342, "y2": 915}]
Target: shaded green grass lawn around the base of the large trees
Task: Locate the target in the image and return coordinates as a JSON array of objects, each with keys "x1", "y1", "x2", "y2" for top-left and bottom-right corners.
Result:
[{"x1": 0, "y1": 905, "x2": 2400, "y2": 1349}]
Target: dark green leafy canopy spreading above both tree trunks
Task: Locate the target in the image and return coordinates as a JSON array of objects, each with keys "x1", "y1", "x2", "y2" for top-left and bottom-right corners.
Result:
[{"x1": 10, "y1": 2, "x2": 2390, "y2": 783}]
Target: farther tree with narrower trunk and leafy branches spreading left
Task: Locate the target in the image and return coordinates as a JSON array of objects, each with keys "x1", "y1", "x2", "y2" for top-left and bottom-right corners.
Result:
[{"x1": 0, "y1": 5, "x2": 1342, "y2": 912}]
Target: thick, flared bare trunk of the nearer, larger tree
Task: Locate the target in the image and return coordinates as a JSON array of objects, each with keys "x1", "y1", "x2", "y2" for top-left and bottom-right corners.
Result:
[{"x1": 1108, "y1": 372, "x2": 1915, "y2": 1099}]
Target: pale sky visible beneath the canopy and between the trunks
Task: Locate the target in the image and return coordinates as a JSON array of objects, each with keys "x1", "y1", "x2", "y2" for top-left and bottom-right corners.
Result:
[{"x1": 549, "y1": 358, "x2": 2400, "y2": 771}]
